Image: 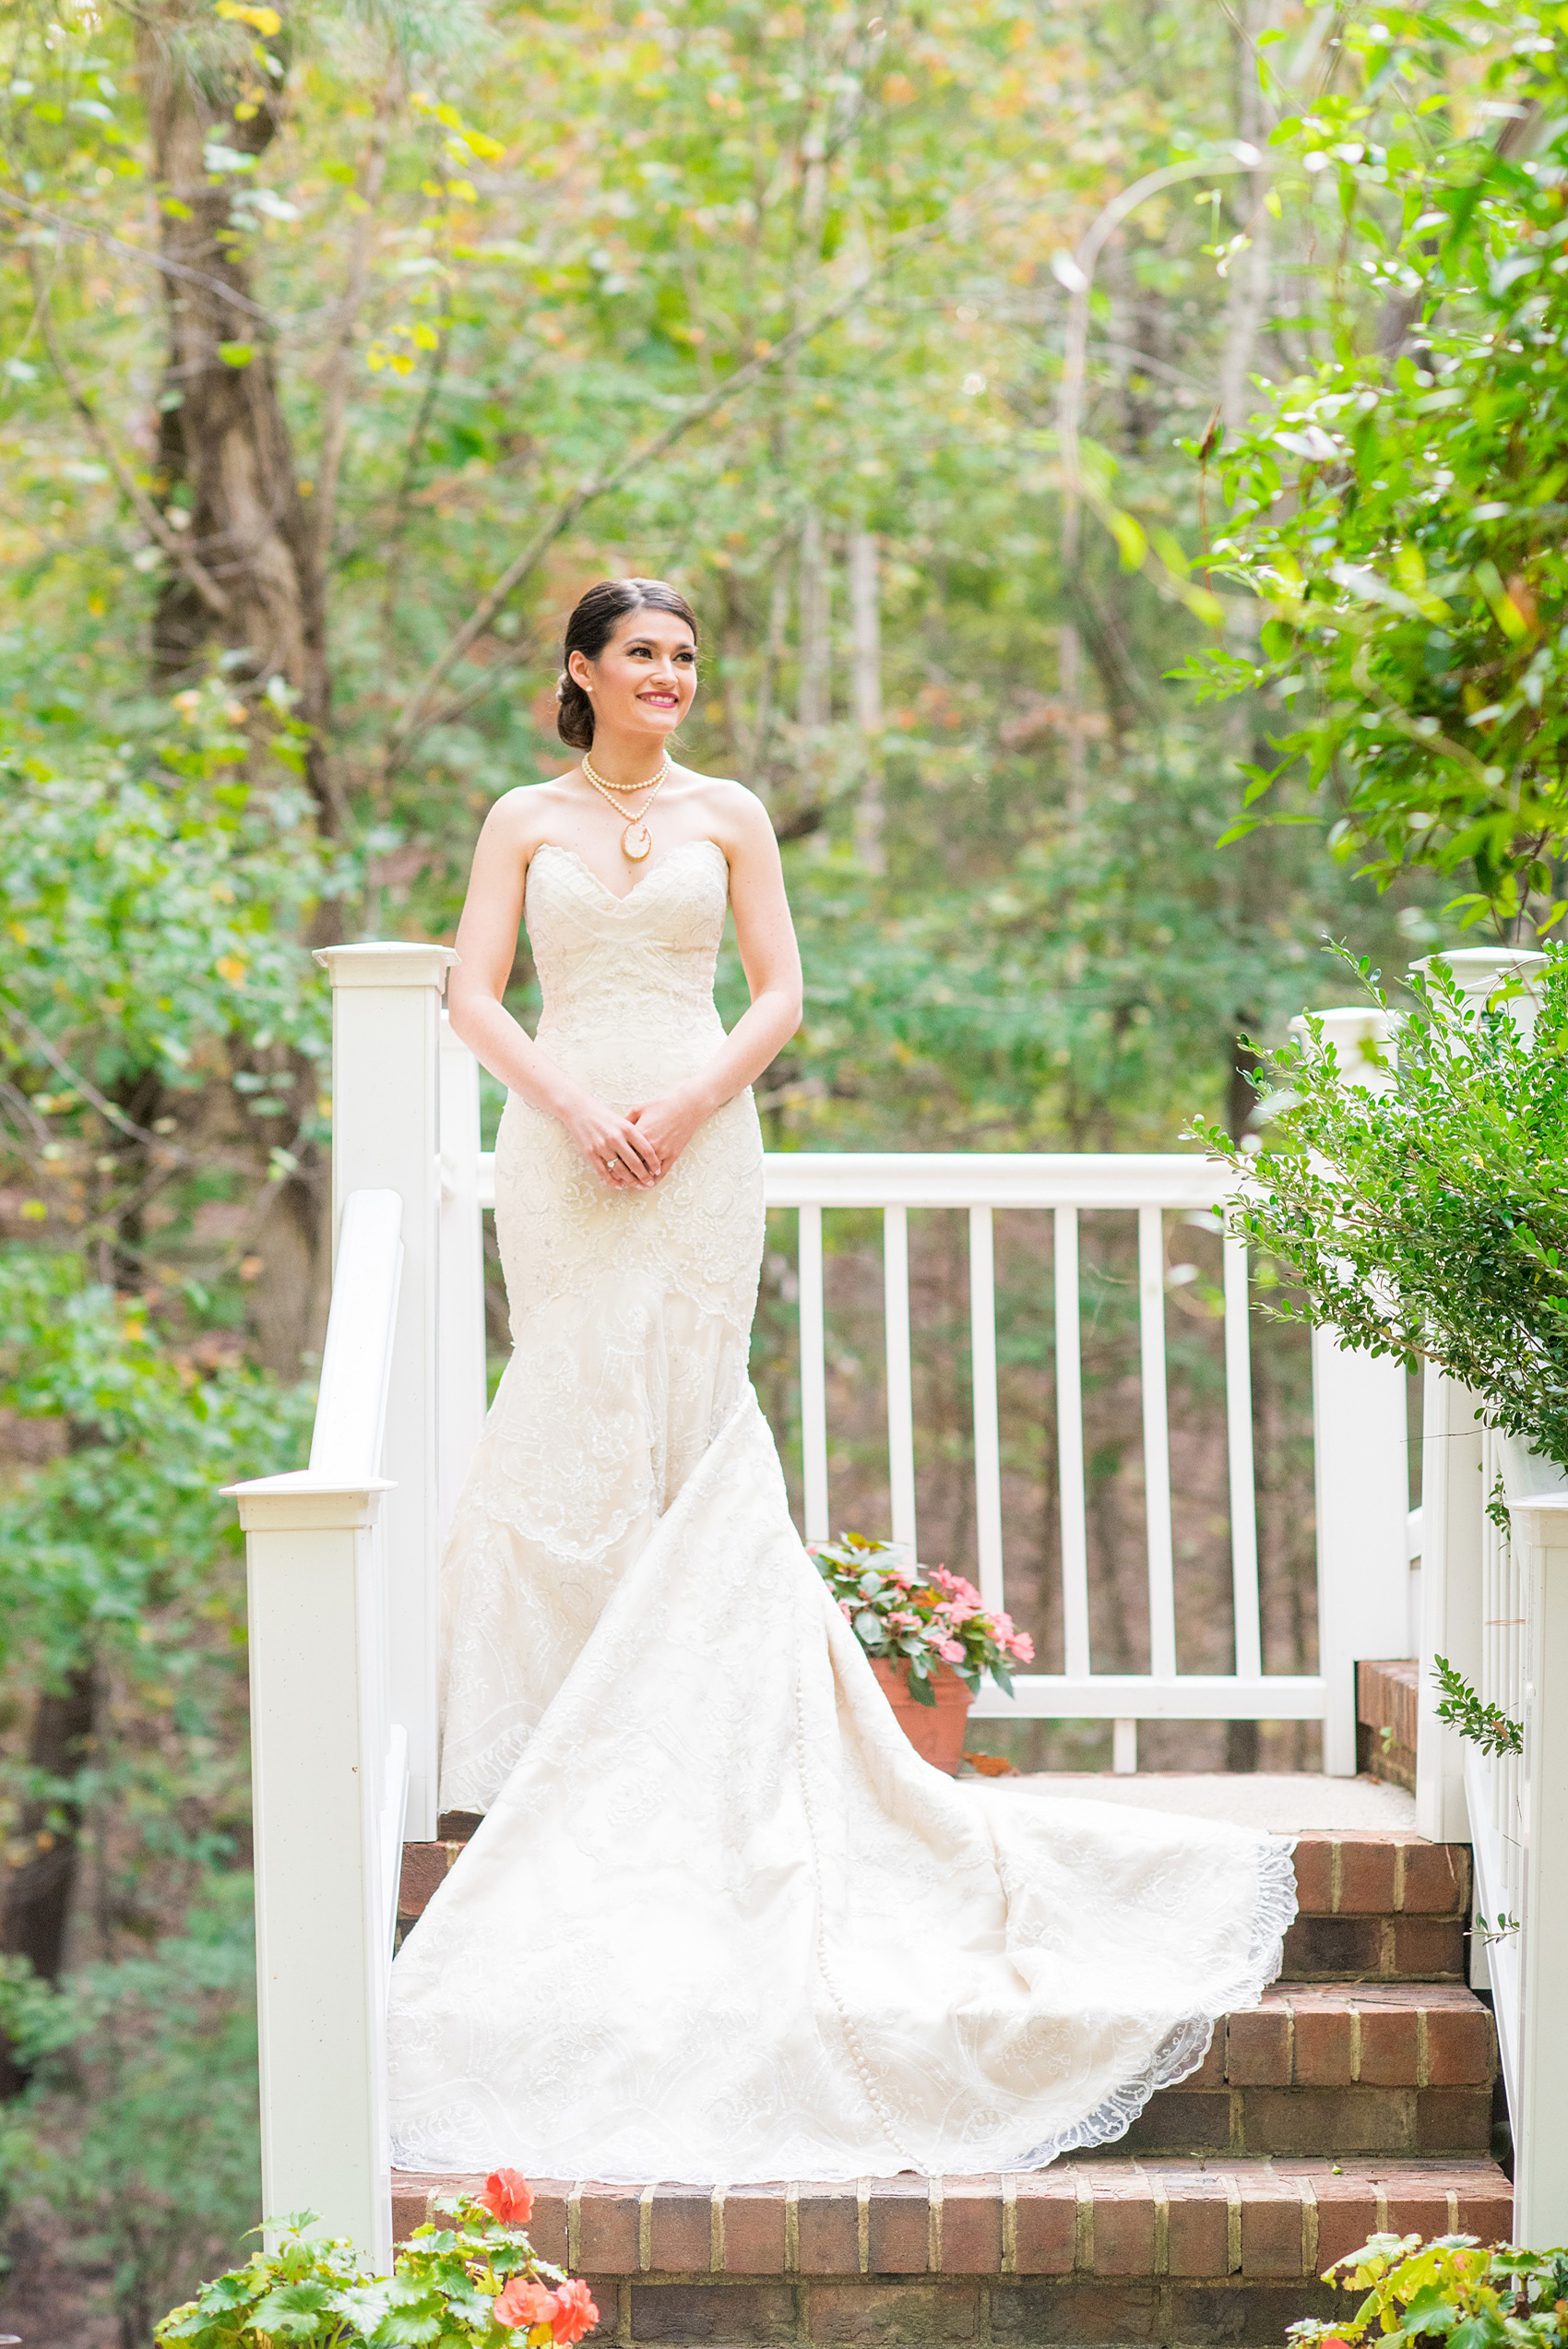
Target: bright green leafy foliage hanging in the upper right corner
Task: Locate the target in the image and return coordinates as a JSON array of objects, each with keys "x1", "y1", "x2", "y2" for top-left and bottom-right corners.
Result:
[{"x1": 1188, "y1": 0, "x2": 1568, "y2": 921}]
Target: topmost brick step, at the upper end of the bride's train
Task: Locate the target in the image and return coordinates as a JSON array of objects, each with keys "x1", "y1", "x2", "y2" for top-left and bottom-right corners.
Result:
[{"x1": 399, "y1": 1814, "x2": 1469, "y2": 1983}]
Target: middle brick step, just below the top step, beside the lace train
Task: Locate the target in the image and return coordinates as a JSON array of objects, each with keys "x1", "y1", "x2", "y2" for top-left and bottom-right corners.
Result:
[{"x1": 1127, "y1": 1983, "x2": 1498, "y2": 2159}]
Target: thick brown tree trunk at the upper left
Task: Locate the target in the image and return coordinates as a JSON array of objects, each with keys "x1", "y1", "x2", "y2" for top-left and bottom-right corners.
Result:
[{"x1": 138, "y1": 0, "x2": 343, "y2": 834}]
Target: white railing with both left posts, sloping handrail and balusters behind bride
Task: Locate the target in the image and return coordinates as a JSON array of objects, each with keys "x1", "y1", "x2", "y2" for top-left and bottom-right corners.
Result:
[{"x1": 240, "y1": 944, "x2": 1410, "y2": 2260}]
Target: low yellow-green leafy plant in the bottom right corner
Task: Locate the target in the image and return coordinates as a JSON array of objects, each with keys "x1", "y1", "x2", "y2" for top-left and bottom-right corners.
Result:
[{"x1": 1291, "y1": 2234, "x2": 1568, "y2": 2349}]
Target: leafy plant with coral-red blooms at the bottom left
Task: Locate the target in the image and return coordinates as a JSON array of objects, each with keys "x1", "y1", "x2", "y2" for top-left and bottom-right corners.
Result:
[{"x1": 155, "y1": 2171, "x2": 599, "y2": 2349}]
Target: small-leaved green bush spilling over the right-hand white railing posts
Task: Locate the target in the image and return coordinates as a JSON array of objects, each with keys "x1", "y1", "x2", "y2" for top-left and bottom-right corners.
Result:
[{"x1": 1193, "y1": 949, "x2": 1568, "y2": 1468}]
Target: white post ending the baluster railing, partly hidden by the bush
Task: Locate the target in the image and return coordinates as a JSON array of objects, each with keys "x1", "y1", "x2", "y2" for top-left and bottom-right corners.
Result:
[{"x1": 1293, "y1": 1006, "x2": 1410, "y2": 1778}]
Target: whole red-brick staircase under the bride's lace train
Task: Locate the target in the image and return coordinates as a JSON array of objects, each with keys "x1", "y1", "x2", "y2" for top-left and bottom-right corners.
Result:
[{"x1": 395, "y1": 1820, "x2": 1512, "y2": 2349}]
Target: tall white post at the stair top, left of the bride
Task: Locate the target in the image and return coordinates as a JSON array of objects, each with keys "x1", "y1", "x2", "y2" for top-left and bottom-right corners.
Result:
[{"x1": 317, "y1": 944, "x2": 456, "y2": 1840}]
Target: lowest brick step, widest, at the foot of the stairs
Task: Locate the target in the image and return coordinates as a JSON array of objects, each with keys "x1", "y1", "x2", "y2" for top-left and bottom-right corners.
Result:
[{"x1": 395, "y1": 2156, "x2": 1512, "y2": 2349}]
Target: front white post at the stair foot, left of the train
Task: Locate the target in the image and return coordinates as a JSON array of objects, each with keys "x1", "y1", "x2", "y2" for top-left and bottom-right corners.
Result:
[{"x1": 234, "y1": 1471, "x2": 392, "y2": 2271}]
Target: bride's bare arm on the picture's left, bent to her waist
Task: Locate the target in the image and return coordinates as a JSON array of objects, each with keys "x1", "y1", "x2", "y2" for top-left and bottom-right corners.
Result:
[{"x1": 446, "y1": 792, "x2": 662, "y2": 1188}]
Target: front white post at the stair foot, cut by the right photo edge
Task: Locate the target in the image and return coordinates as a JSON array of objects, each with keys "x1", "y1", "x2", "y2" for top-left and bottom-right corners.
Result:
[{"x1": 1509, "y1": 1492, "x2": 1568, "y2": 2250}]
